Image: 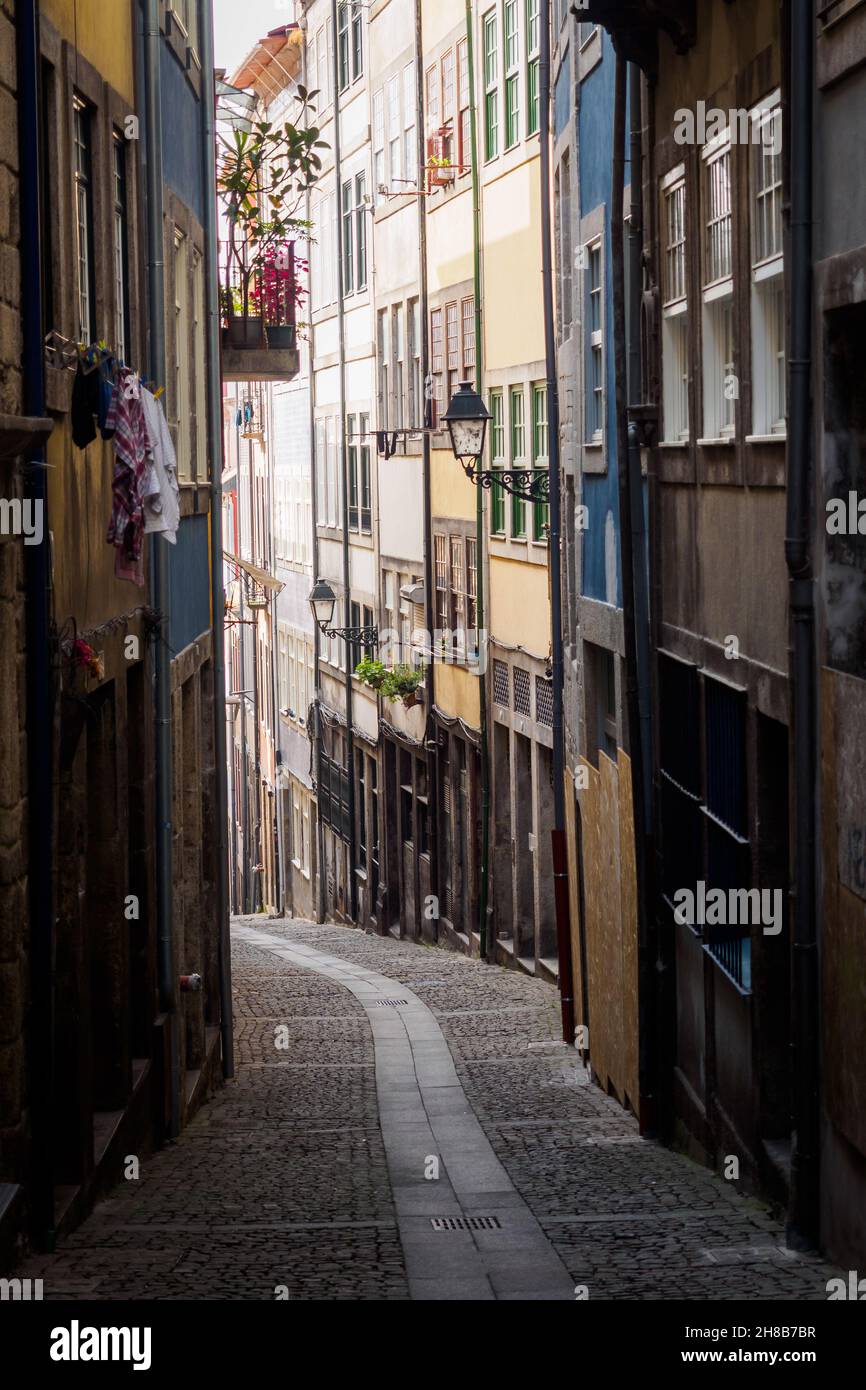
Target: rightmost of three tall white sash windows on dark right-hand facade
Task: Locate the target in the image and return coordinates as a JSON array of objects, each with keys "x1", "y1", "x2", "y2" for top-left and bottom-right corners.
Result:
[{"x1": 751, "y1": 93, "x2": 787, "y2": 435}]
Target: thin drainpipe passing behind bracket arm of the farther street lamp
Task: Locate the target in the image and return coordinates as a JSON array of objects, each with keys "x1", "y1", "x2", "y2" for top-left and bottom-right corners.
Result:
[{"x1": 331, "y1": 0, "x2": 357, "y2": 922}]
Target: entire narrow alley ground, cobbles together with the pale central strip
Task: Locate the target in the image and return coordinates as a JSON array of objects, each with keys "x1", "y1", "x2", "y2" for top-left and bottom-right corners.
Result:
[{"x1": 24, "y1": 917, "x2": 835, "y2": 1300}]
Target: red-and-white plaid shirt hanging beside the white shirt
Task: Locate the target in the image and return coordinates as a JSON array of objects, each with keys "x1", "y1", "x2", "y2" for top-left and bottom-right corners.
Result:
[{"x1": 106, "y1": 368, "x2": 160, "y2": 587}]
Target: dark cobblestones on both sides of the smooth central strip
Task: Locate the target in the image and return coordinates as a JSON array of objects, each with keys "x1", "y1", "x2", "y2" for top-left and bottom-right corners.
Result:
[{"x1": 21, "y1": 917, "x2": 838, "y2": 1301}]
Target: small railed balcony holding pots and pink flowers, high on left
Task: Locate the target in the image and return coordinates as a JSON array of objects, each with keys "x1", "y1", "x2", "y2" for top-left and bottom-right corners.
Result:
[{"x1": 220, "y1": 240, "x2": 303, "y2": 381}]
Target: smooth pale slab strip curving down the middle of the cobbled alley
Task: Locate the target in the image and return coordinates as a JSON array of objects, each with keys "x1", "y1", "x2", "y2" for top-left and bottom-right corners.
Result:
[{"x1": 232, "y1": 926, "x2": 574, "y2": 1300}]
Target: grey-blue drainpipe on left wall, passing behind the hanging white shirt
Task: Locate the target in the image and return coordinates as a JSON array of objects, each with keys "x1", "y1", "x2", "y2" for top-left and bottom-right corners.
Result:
[{"x1": 143, "y1": 0, "x2": 181, "y2": 1137}]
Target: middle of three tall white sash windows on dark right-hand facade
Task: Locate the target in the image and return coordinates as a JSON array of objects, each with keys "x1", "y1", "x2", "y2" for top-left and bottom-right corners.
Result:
[{"x1": 702, "y1": 132, "x2": 737, "y2": 439}]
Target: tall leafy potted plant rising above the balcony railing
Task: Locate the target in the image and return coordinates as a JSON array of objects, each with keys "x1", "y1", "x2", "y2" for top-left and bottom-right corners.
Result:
[{"x1": 218, "y1": 88, "x2": 325, "y2": 348}]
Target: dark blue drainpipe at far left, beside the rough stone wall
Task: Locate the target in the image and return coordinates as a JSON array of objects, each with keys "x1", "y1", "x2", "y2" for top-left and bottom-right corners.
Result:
[{"x1": 15, "y1": 0, "x2": 54, "y2": 1251}]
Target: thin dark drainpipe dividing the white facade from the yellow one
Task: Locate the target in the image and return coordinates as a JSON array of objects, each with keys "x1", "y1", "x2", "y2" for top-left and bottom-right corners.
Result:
[{"x1": 413, "y1": 0, "x2": 439, "y2": 922}]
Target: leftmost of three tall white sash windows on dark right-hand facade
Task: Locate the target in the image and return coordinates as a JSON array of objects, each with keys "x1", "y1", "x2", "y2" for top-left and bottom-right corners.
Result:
[{"x1": 662, "y1": 168, "x2": 688, "y2": 443}]
